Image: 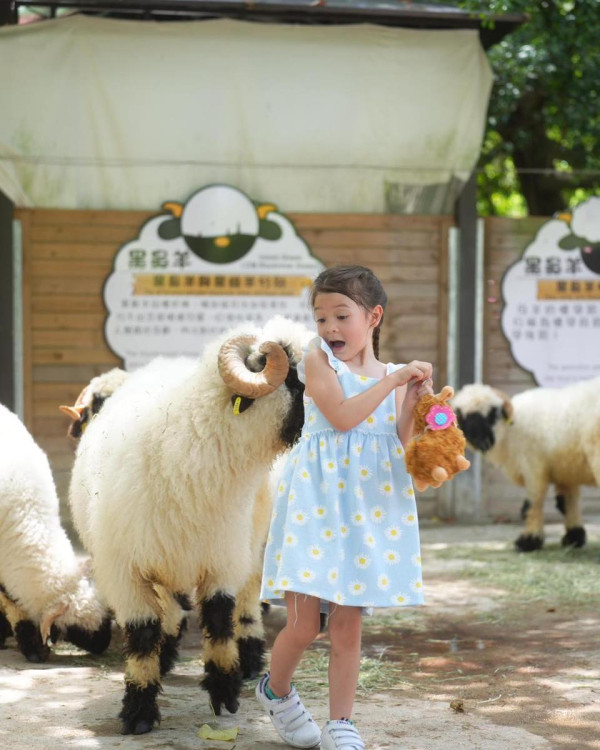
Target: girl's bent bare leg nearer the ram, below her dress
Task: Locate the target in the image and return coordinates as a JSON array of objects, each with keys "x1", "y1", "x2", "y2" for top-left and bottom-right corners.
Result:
[{"x1": 269, "y1": 591, "x2": 320, "y2": 697}]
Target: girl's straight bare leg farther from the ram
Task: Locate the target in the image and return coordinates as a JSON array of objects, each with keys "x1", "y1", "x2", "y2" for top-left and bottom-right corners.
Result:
[{"x1": 329, "y1": 606, "x2": 362, "y2": 719}]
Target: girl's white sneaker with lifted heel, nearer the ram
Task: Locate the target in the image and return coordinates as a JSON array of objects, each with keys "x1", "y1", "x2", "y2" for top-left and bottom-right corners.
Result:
[{"x1": 255, "y1": 673, "x2": 321, "y2": 748}]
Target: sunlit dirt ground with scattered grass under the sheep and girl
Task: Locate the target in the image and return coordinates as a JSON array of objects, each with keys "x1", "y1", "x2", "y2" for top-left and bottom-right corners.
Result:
[{"x1": 0, "y1": 517, "x2": 600, "y2": 750}]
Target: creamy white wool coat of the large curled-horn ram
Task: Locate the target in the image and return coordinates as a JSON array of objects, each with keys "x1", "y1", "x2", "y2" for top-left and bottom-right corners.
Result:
[{"x1": 70, "y1": 318, "x2": 310, "y2": 624}]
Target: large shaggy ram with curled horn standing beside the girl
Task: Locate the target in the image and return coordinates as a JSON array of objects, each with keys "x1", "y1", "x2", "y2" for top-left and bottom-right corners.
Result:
[{"x1": 70, "y1": 318, "x2": 311, "y2": 734}]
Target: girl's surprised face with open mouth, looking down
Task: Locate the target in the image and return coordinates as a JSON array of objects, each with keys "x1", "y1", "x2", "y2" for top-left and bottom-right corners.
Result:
[{"x1": 314, "y1": 292, "x2": 383, "y2": 361}]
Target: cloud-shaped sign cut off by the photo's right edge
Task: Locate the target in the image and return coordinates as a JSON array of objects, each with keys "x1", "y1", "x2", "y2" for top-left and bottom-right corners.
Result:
[{"x1": 501, "y1": 197, "x2": 600, "y2": 387}]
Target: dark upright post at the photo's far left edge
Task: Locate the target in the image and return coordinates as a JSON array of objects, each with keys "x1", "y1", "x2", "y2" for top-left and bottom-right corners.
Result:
[{"x1": 0, "y1": 192, "x2": 15, "y2": 411}]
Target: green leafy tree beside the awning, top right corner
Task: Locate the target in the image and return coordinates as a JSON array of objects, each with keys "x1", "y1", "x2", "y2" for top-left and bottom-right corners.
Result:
[{"x1": 459, "y1": 0, "x2": 600, "y2": 215}]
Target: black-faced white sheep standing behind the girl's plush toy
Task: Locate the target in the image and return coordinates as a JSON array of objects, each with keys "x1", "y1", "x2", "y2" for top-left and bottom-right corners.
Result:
[{"x1": 452, "y1": 378, "x2": 600, "y2": 552}]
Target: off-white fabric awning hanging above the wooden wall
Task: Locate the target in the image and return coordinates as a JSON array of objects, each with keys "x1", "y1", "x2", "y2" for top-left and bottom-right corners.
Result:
[{"x1": 0, "y1": 16, "x2": 492, "y2": 212}]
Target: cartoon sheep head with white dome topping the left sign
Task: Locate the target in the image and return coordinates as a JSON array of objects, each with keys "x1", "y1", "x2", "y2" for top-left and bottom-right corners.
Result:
[{"x1": 158, "y1": 185, "x2": 282, "y2": 263}]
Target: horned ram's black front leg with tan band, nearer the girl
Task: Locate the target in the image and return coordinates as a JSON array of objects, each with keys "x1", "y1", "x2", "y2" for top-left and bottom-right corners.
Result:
[{"x1": 200, "y1": 592, "x2": 242, "y2": 715}]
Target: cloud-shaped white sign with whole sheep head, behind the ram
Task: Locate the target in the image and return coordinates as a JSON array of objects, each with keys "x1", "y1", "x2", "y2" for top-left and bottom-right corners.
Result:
[{"x1": 104, "y1": 185, "x2": 324, "y2": 370}]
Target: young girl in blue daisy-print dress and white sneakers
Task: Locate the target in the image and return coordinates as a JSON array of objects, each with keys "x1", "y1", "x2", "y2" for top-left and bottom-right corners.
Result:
[{"x1": 256, "y1": 266, "x2": 432, "y2": 750}]
